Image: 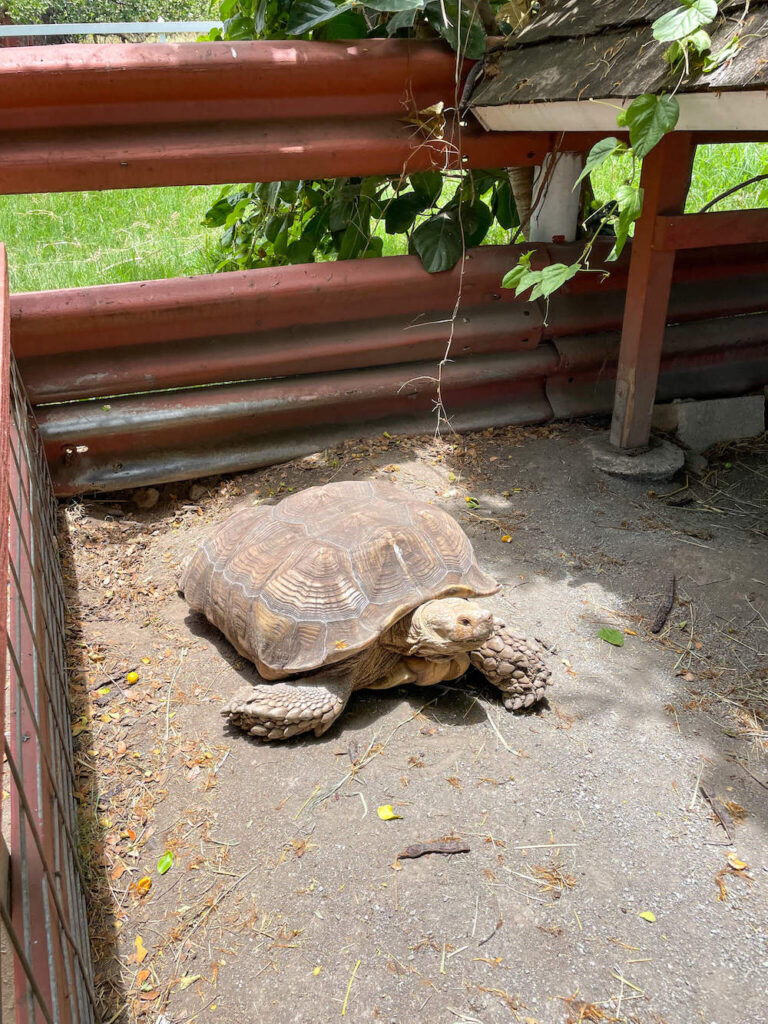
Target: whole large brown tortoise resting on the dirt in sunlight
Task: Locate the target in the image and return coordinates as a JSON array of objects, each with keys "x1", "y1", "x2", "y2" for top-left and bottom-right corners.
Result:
[{"x1": 179, "y1": 480, "x2": 548, "y2": 739}]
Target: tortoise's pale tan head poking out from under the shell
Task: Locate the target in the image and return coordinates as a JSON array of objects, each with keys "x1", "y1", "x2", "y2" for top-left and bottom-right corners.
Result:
[{"x1": 381, "y1": 597, "x2": 494, "y2": 657}]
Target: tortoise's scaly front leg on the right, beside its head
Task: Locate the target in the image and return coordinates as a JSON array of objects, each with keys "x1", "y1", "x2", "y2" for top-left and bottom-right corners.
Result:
[{"x1": 470, "y1": 618, "x2": 552, "y2": 711}]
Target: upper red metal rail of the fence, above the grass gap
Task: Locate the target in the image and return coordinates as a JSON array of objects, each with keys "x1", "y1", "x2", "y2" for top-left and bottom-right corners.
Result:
[{"x1": 0, "y1": 39, "x2": 610, "y2": 194}]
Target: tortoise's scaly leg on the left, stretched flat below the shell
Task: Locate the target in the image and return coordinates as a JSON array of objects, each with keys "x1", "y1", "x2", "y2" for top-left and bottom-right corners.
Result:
[{"x1": 221, "y1": 674, "x2": 352, "y2": 739}]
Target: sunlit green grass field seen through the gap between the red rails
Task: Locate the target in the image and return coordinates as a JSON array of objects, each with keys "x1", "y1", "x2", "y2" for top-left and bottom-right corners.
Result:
[{"x1": 0, "y1": 142, "x2": 768, "y2": 292}]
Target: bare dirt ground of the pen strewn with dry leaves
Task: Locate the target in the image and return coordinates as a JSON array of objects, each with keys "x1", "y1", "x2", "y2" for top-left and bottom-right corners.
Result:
[{"x1": 61, "y1": 423, "x2": 768, "y2": 1024}]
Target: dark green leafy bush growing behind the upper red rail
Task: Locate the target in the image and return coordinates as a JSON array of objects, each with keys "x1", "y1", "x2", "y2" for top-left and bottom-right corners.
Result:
[{"x1": 206, "y1": 0, "x2": 518, "y2": 273}]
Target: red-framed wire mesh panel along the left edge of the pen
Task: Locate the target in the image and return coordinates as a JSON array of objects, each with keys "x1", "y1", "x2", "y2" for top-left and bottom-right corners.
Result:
[{"x1": 0, "y1": 245, "x2": 95, "y2": 1024}]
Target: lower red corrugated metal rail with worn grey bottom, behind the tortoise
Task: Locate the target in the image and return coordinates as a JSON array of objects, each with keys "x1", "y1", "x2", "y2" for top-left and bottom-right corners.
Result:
[{"x1": 11, "y1": 240, "x2": 768, "y2": 495}]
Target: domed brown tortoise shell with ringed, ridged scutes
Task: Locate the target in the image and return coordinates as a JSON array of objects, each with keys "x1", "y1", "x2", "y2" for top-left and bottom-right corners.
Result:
[{"x1": 179, "y1": 480, "x2": 499, "y2": 679}]
